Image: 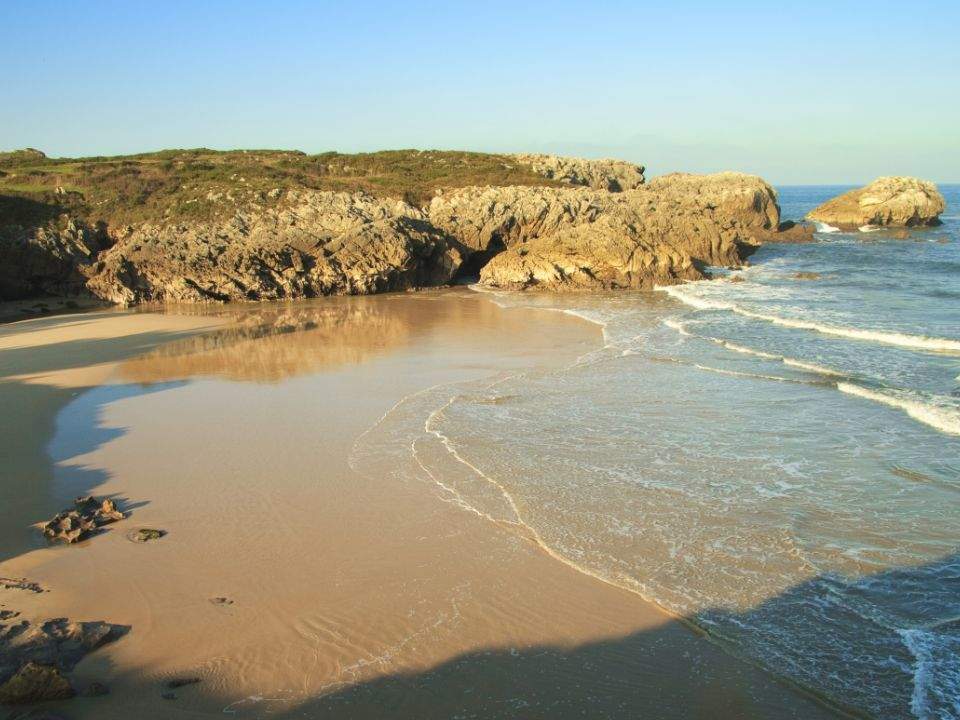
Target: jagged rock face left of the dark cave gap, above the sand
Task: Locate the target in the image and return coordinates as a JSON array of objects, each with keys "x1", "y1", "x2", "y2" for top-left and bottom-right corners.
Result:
[{"x1": 87, "y1": 191, "x2": 461, "y2": 304}]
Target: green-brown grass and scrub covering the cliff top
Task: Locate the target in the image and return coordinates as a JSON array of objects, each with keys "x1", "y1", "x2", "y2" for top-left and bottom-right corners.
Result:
[{"x1": 0, "y1": 148, "x2": 557, "y2": 228}]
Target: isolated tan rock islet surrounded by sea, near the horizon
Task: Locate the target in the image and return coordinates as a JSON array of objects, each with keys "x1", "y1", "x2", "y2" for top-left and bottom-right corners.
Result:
[{"x1": 807, "y1": 177, "x2": 946, "y2": 230}]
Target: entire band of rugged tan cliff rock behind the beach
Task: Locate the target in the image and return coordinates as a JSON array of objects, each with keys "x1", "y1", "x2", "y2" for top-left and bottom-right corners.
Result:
[{"x1": 0, "y1": 156, "x2": 796, "y2": 304}]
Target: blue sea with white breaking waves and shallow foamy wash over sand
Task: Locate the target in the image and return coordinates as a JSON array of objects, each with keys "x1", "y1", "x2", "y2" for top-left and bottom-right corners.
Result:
[{"x1": 354, "y1": 186, "x2": 960, "y2": 720}]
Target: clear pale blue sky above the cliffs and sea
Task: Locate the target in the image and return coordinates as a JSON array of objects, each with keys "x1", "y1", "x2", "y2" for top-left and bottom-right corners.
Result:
[{"x1": 0, "y1": 0, "x2": 960, "y2": 183}]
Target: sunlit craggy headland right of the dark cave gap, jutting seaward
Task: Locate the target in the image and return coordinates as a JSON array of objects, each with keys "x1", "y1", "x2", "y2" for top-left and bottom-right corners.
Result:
[{"x1": 429, "y1": 173, "x2": 780, "y2": 290}]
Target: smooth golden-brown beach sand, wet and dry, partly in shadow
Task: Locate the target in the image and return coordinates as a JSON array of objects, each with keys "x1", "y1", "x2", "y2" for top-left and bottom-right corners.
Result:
[{"x1": 0, "y1": 291, "x2": 834, "y2": 718}]
